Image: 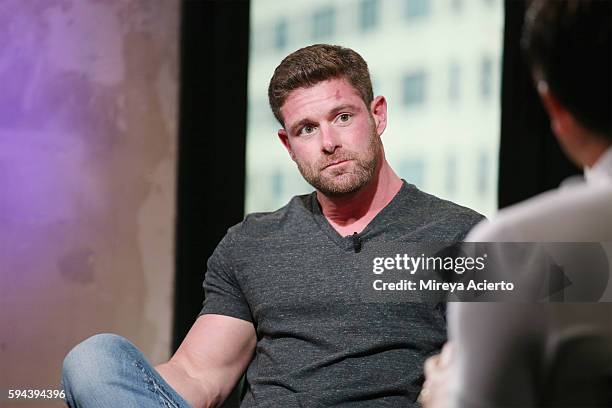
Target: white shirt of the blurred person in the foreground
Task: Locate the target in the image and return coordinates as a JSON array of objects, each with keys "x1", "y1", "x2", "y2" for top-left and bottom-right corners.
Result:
[{"x1": 446, "y1": 148, "x2": 612, "y2": 407}]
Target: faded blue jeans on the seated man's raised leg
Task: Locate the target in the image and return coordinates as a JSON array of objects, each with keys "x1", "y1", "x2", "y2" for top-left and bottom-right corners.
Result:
[{"x1": 62, "y1": 334, "x2": 190, "y2": 408}]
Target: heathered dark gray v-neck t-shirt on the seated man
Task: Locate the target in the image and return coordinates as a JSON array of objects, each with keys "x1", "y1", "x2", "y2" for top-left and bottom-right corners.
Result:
[{"x1": 201, "y1": 181, "x2": 483, "y2": 407}]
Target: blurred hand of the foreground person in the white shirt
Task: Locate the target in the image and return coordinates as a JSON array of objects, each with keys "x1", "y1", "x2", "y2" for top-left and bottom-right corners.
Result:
[{"x1": 419, "y1": 343, "x2": 453, "y2": 408}]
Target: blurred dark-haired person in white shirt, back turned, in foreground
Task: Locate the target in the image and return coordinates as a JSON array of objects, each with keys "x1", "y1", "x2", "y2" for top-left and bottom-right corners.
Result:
[{"x1": 421, "y1": 0, "x2": 612, "y2": 408}]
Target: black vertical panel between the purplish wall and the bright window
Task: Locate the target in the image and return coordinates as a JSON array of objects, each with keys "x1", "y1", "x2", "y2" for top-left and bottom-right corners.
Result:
[{"x1": 173, "y1": 0, "x2": 249, "y2": 349}]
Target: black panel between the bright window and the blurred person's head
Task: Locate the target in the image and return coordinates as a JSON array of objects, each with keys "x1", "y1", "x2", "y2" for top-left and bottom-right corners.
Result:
[{"x1": 498, "y1": 0, "x2": 581, "y2": 208}]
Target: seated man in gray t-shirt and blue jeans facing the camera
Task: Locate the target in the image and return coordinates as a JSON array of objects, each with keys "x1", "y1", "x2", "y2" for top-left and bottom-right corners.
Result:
[{"x1": 63, "y1": 44, "x2": 482, "y2": 407}]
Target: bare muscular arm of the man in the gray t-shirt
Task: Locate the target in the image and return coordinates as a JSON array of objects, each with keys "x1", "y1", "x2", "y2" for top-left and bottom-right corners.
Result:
[{"x1": 155, "y1": 314, "x2": 257, "y2": 408}]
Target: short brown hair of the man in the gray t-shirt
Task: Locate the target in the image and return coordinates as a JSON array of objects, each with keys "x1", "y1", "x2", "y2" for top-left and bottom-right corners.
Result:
[{"x1": 268, "y1": 44, "x2": 374, "y2": 126}]
